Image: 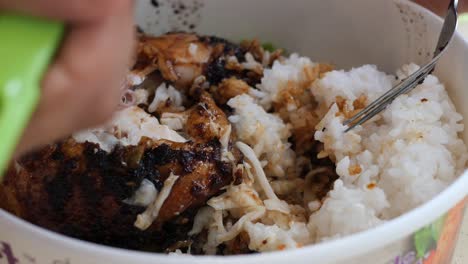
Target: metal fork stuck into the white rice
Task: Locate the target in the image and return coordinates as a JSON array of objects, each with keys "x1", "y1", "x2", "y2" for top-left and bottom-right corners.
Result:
[{"x1": 343, "y1": 0, "x2": 458, "y2": 132}]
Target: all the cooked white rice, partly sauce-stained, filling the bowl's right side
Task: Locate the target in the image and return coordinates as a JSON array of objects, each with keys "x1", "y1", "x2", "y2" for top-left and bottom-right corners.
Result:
[{"x1": 192, "y1": 55, "x2": 467, "y2": 253}]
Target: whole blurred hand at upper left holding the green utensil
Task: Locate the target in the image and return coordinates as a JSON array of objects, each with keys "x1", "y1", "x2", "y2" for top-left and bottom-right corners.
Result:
[{"x1": 0, "y1": 0, "x2": 134, "y2": 155}]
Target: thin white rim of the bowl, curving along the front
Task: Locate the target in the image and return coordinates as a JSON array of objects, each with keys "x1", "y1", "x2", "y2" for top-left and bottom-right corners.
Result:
[{"x1": 0, "y1": 0, "x2": 468, "y2": 263}]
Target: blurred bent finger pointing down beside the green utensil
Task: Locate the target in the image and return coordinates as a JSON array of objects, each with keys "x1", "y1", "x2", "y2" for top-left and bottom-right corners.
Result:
[{"x1": 17, "y1": 2, "x2": 134, "y2": 154}]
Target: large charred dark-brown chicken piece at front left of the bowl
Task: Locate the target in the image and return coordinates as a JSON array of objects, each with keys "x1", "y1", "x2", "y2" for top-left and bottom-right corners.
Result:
[{"x1": 0, "y1": 136, "x2": 238, "y2": 250}]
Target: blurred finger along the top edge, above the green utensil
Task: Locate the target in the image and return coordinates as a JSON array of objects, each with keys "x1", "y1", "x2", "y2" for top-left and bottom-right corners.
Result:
[{"x1": 0, "y1": 0, "x2": 131, "y2": 22}]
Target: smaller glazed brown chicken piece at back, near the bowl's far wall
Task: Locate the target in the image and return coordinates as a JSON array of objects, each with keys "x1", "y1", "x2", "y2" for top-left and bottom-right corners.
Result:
[{"x1": 131, "y1": 33, "x2": 261, "y2": 90}]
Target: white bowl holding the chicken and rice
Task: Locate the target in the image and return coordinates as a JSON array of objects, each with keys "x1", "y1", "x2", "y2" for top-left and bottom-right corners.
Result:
[{"x1": 0, "y1": 0, "x2": 468, "y2": 264}]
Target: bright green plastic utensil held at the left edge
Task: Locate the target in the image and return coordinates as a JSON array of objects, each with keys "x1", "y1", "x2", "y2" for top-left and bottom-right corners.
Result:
[{"x1": 0, "y1": 13, "x2": 64, "y2": 180}]
